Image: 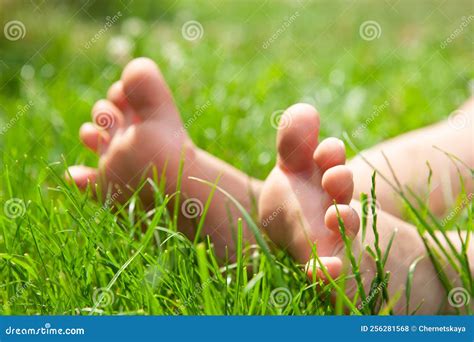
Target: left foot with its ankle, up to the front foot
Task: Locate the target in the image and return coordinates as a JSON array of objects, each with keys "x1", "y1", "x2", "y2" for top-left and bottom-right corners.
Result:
[{"x1": 69, "y1": 58, "x2": 260, "y2": 256}]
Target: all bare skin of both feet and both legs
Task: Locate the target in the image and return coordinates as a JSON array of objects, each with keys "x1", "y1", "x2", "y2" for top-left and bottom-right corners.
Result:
[{"x1": 68, "y1": 58, "x2": 474, "y2": 313}]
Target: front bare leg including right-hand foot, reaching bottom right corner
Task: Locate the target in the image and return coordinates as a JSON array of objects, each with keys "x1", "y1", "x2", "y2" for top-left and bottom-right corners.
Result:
[{"x1": 259, "y1": 104, "x2": 474, "y2": 314}]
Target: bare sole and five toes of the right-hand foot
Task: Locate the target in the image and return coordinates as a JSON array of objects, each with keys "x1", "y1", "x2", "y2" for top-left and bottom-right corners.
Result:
[{"x1": 259, "y1": 104, "x2": 359, "y2": 277}]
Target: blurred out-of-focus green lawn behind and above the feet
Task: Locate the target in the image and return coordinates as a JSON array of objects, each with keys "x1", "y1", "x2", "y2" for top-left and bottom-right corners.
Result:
[{"x1": 0, "y1": 0, "x2": 473, "y2": 182}]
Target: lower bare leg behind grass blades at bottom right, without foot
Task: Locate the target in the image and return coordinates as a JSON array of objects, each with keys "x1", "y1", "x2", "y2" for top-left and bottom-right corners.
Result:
[{"x1": 338, "y1": 200, "x2": 474, "y2": 314}]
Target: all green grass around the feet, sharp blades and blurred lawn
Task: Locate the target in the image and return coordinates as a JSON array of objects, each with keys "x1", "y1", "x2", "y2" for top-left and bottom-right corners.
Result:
[{"x1": 0, "y1": 1, "x2": 473, "y2": 315}]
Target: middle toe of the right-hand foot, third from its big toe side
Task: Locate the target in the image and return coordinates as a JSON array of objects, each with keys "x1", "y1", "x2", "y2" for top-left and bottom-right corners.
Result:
[{"x1": 321, "y1": 165, "x2": 354, "y2": 204}]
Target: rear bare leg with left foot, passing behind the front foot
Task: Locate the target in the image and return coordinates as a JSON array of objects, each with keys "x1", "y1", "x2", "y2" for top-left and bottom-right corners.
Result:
[{"x1": 70, "y1": 59, "x2": 474, "y2": 278}]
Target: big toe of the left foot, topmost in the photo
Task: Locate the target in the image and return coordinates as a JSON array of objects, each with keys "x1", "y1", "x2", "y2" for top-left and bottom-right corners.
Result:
[{"x1": 122, "y1": 57, "x2": 179, "y2": 120}]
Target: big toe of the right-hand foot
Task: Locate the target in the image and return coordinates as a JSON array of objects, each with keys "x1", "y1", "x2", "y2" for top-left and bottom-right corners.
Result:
[{"x1": 277, "y1": 103, "x2": 319, "y2": 172}]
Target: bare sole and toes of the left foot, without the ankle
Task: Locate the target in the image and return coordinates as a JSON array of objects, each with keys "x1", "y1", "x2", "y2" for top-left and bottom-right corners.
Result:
[{"x1": 69, "y1": 58, "x2": 195, "y2": 199}]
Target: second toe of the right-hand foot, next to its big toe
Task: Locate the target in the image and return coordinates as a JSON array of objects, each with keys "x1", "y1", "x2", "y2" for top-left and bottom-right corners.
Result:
[{"x1": 313, "y1": 138, "x2": 346, "y2": 172}]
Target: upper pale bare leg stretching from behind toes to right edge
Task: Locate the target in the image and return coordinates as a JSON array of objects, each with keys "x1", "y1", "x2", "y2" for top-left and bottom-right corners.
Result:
[{"x1": 348, "y1": 98, "x2": 474, "y2": 217}]
